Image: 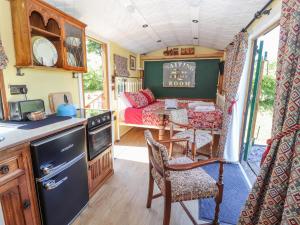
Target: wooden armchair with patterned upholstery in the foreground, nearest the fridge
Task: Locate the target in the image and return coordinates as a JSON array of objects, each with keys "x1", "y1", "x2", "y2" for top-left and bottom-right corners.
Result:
[{"x1": 145, "y1": 130, "x2": 223, "y2": 225}]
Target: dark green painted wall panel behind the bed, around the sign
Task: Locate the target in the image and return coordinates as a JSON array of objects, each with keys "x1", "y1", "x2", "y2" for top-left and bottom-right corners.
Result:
[{"x1": 144, "y1": 59, "x2": 220, "y2": 99}]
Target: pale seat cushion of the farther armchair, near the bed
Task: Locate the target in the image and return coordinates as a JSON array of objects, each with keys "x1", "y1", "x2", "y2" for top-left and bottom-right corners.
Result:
[{"x1": 173, "y1": 130, "x2": 213, "y2": 149}]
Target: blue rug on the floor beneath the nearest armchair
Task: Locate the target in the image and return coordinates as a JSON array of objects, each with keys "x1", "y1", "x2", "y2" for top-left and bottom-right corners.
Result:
[{"x1": 199, "y1": 163, "x2": 250, "y2": 224}]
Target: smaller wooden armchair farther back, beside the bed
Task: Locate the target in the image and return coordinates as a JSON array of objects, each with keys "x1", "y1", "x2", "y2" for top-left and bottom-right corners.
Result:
[{"x1": 169, "y1": 109, "x2": 213, "y2": 160}]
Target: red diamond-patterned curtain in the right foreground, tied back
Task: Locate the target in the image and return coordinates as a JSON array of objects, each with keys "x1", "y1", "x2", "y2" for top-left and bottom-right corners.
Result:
[{"x1": 238, "y1": 0, "x2": 300, "y2": 225}]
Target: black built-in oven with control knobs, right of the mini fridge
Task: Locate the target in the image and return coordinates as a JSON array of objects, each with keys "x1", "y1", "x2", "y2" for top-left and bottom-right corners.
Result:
[{"x1": 87, "y1": 111, "x2": 112, "y2": 160}]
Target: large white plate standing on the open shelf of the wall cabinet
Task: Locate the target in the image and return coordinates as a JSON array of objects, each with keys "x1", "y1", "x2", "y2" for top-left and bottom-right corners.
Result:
[{"x1": 32, "y1": 36, "x2": 58, "y2": 66}]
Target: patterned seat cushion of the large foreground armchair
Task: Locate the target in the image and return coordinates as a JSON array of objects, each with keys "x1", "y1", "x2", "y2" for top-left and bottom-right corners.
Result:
[{"x1": 151, "y1": 157, "x2": 218, "y2": 202}]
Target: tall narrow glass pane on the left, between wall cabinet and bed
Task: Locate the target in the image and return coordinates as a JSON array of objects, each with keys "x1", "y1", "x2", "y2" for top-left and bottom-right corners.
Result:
[{"x1": 83, "y1": 39, "x2": 104, "y2": 109}]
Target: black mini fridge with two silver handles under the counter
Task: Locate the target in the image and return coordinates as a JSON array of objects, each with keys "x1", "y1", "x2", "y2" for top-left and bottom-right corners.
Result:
[{"x1": 31, "y1": 127, "x2": 89, "y2": 225}]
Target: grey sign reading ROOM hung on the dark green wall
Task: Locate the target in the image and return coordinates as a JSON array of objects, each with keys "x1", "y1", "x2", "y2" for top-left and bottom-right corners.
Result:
[{"x1": 163, "y1": 62, "x2": 196, "y2": 88}]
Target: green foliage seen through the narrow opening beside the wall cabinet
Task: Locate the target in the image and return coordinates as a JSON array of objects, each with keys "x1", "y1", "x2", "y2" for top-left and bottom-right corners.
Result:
[{"x1": 83, "y1": 39, "x2": 103, "y2": 92}]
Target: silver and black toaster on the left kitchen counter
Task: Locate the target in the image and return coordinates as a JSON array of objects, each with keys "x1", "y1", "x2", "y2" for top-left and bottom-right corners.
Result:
[{"x1": 8, "y1": 99, "x2": 45, "y2": 121}]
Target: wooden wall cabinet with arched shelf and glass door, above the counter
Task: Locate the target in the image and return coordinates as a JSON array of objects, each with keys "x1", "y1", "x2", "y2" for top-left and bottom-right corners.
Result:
[{"x1": 10, "y1": 0, "x2": 87, "y2": 72}]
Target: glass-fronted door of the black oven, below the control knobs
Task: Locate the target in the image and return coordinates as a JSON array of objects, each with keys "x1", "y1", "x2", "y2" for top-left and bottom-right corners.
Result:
[{"x1": 88, "y1": 123, "x2": 112, "y2": 160}]
